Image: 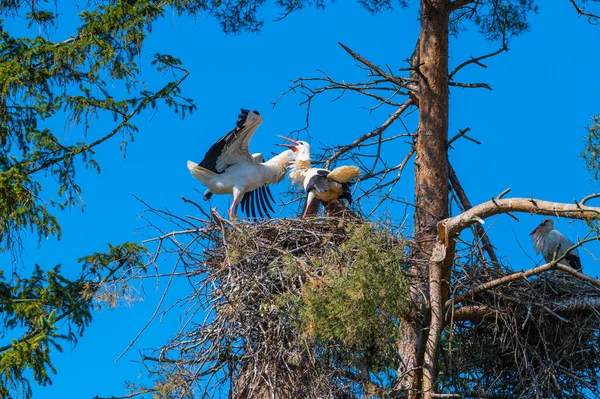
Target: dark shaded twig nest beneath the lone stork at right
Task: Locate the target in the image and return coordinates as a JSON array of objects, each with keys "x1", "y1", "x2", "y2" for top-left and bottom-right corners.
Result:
[{"x1": 444, "y1": 266, "x2": 600, "y2": 398}]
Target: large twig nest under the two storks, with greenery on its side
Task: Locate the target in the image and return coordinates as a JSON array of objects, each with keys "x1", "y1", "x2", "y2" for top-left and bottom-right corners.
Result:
[{"x1": 147, "y1": 214, "x2": 410, "y2": 398}]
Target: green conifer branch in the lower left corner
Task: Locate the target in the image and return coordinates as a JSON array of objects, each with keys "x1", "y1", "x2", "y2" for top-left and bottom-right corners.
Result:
[{"x1": 0, "y1": 243, "x2": 143, "y2": 398}]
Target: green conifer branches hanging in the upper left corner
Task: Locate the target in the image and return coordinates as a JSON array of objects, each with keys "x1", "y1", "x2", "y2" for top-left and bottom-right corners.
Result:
[{"x1": 0, "y1": 1, "x2": 195, "y2": 253}]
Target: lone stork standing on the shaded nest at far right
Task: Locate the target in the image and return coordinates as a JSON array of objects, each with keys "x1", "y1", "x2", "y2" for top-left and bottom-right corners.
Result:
[{"x1": 530, "y1": 219, "x2": 581, "y2": 270}]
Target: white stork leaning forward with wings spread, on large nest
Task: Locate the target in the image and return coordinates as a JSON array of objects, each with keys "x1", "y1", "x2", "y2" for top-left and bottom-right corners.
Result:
[{"x1": 187, "y1": 109, "x2": 294, "y2": 219}]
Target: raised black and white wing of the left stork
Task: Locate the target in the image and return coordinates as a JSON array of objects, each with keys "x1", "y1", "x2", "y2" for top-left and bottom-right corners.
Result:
[{"x1": 199, "y1": 109, "x2": 262, "y2": 173}]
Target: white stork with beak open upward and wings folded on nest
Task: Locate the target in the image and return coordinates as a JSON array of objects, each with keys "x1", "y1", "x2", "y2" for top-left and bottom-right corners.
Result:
[{"x1": 278, "y1": 136, "x2": 360, "y2": 218}]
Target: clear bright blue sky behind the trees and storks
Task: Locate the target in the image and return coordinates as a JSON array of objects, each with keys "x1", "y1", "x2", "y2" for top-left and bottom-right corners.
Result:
[{"x1": 9, "y1": 0, "x2": 600, "y2": 399}]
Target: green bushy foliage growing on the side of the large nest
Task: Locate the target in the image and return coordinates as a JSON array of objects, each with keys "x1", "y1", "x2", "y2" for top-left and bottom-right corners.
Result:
[{"x1": 301, "y1": 224, "x2": 410, "y2": 368}]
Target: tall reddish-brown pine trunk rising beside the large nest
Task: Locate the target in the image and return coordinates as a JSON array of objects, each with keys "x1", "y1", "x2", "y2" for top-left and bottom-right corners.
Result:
[{"x1": 399, "y1": 0, "x2": 450, "y2": 398}]
